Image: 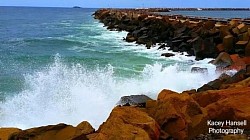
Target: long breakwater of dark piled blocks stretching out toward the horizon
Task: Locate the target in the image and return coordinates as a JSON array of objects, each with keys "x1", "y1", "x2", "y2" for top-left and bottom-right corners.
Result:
[{"x1": 93, "y1": 9, "x2": 250, "y2": 67}]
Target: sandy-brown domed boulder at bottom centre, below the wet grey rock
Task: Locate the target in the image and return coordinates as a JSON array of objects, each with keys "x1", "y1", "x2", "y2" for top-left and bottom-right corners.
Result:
[{"x1": 92, "y1": 106, "x2": 160, "y2": 140}]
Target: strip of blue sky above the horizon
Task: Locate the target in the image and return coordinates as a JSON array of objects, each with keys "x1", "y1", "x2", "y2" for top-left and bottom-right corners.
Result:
[{"x1": 0, "y1": 0, "x2": 250, "y2": 8}]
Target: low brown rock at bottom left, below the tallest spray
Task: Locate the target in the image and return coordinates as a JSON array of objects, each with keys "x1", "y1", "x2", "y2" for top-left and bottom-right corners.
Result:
[{"x1": 7, "y1": 121, "x2": 94, "y2": 140}]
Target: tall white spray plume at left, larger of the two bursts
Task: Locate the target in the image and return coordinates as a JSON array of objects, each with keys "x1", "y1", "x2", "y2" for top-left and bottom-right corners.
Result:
[{"x1": 0, "y1": 55, "x2": 113, "y2": 128}]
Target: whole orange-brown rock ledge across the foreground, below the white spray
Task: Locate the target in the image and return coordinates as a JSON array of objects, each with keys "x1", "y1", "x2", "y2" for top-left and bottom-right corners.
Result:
[{"x1": 0, "y1": 68, "x2": 250, "y2": 140}]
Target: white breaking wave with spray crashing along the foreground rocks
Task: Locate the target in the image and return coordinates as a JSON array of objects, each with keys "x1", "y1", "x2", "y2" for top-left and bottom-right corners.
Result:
[{"x1": 0, "y1": 55, "x2": 218, "y2": 129}]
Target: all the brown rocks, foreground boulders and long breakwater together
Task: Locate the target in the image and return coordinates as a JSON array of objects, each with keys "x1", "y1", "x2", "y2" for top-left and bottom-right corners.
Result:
[{"x1": 0, "y1": 9, "x2": 250, "y2": 140}]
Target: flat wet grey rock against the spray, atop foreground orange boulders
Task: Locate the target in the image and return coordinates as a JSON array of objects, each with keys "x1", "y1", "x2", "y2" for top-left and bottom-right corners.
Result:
[{"x1": 117, "y1": 95, "x2": 152, "y2": 107}]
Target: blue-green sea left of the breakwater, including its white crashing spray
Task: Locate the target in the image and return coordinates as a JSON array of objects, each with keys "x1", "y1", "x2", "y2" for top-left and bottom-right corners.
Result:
[{"x1": 0, "y1": 7, "x2": 225, "y2": 129}]
